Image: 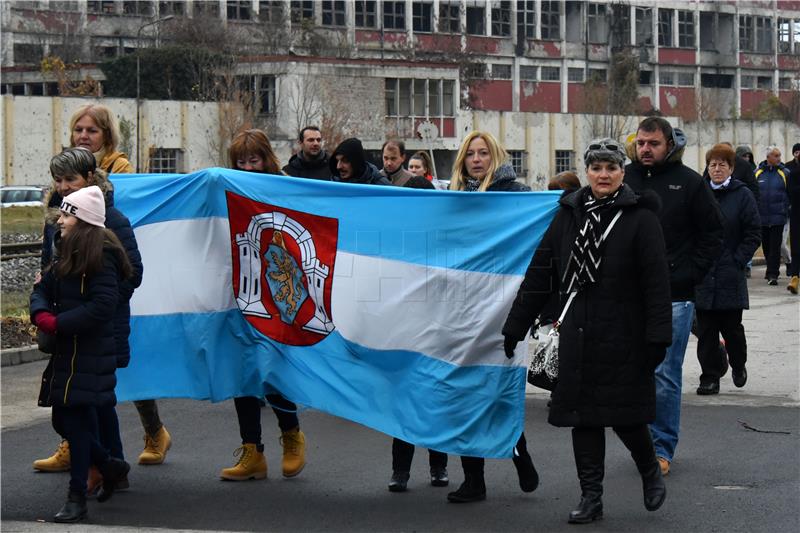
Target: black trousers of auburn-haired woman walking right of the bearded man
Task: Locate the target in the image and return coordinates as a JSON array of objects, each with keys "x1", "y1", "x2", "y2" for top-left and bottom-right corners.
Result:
[{"x1": 695, "y1": 309, "x2": 747, "y2": 381}]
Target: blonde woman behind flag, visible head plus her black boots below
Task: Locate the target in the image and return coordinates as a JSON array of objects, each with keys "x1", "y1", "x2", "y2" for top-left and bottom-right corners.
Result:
[{"x1": 447, "y1": 131, "x2": 539, "y2": 503}]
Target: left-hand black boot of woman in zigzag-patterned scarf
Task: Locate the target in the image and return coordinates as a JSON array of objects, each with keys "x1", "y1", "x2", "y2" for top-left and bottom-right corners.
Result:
[{"x1": 568, "y1": 428, "x2": 606, "y2": 524}]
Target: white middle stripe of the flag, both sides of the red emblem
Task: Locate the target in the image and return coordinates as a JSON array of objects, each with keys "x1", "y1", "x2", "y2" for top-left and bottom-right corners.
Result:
[{"x1": 131, "y1": 217, "x2": 527, "y2": 365}]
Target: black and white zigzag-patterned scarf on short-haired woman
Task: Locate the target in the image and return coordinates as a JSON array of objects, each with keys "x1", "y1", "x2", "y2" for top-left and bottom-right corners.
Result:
[{"x1": 563, "y1": 187, "x2": 622, "y2": 293}]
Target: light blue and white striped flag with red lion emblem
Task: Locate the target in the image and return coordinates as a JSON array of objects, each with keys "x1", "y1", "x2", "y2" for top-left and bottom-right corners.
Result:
[{"x1": 112, "y1": 168, "x2": 559, "y2": 457}]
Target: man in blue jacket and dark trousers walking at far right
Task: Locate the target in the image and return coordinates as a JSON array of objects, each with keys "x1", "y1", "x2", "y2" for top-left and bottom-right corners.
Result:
[{"x1": 756, "y1": 146, "x2": 789, "y2": 285}]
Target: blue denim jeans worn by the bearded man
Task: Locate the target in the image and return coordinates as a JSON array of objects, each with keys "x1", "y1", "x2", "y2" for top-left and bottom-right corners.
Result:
[{"x1": 650, "y1": 302, "x2": 694, "y2": 461}]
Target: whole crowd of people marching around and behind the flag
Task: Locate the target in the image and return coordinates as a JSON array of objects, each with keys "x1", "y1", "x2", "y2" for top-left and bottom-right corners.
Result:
[{"x1": 30, "y1": 104, "x2": 800, "y2": 524}]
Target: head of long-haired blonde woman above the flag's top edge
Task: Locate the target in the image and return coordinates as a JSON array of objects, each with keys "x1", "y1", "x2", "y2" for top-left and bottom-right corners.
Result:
[{"x1": 450, "y1": 131, "x2": 530, "y2": 192}]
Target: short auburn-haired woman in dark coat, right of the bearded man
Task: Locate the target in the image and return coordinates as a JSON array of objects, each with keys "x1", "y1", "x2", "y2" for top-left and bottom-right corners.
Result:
[{"x1": 695, "y1": 144, "x2": 761, "y2": 395}]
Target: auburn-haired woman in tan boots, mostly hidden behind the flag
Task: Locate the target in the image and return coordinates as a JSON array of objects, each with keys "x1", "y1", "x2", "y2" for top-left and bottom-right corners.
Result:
[{"x1": 219, "y1": 129, "x2": 306, "y2": 481}]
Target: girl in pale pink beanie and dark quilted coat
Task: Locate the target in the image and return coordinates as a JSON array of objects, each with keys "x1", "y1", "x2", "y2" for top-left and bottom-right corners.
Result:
[{"x1": 30, "y1": 185, "x2": 132, "y2": 522}]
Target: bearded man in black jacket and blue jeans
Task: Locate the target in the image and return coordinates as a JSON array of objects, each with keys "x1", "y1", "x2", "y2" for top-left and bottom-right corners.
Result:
[{"x1": 625, "y1": 117, "x2": 723, "y2": 474}]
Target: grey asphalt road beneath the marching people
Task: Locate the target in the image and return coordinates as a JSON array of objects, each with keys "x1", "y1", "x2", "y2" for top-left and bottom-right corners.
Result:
[{"x1": 0, "y1": 264, "x2": 800, "y2": 532}]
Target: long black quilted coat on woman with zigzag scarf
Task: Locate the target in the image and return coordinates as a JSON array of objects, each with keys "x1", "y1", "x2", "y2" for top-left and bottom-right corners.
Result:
[{"x1": 503, "y1": 185, "x2": 672, "y2": 426}]
